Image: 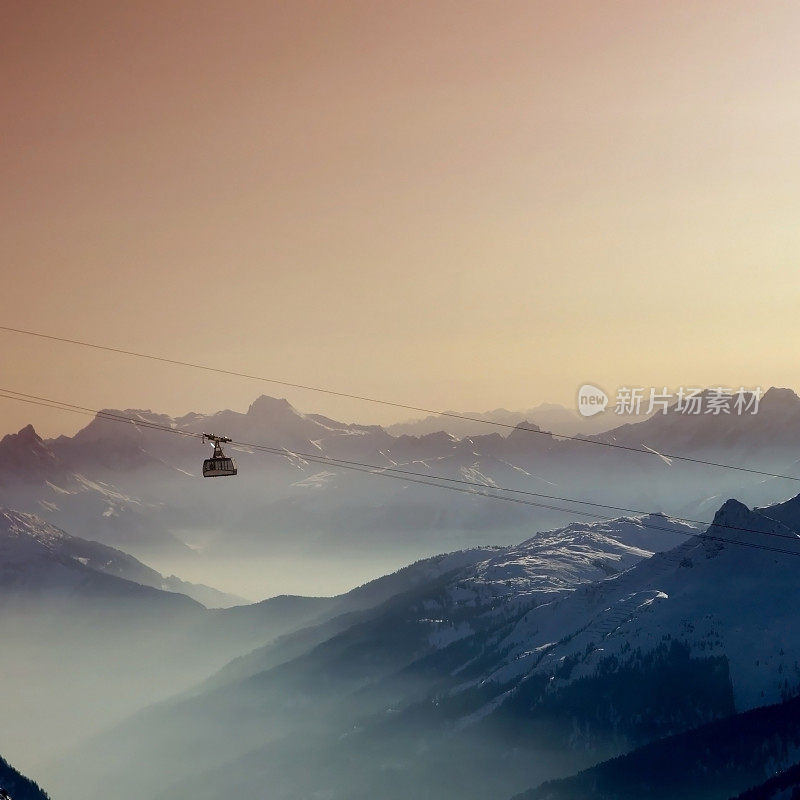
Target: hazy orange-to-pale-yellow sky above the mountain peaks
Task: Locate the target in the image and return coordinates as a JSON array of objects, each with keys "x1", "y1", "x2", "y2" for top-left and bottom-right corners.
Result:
[{"x1": 0, "y1": 0, "x2": 800, "y2": 436}]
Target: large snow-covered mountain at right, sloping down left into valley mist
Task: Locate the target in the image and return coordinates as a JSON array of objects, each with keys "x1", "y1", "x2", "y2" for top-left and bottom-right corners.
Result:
[{"x1": 45, "y1": 500, "x2": 800, "y2": 800}]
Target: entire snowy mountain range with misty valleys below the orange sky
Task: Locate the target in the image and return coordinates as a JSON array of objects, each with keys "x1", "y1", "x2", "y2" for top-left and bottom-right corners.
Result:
[{"x1": 0, "y1": 389, "x2": 800, "y2": 800}]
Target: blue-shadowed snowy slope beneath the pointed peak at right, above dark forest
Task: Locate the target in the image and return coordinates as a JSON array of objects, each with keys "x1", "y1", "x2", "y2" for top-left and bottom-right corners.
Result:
[{"x1": 468, "y1": 500, "x2": 800, "y2": 710}]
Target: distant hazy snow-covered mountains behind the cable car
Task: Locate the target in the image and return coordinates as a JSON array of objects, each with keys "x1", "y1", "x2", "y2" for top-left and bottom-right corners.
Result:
[{"x1": 0, "y1": 389, "x2": 800, "y2": 580}]
